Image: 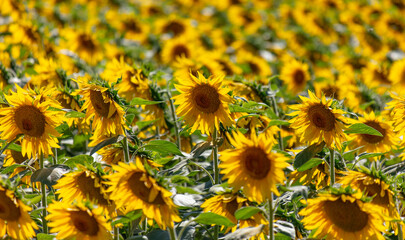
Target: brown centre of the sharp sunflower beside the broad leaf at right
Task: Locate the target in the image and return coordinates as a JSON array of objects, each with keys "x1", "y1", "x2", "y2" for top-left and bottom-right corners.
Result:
[{"x1": 308, "y1": 104, "x2": 336, "y2": 131}]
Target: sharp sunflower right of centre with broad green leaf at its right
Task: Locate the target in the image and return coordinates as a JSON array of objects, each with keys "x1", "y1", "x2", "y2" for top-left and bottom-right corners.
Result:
[{"x1": 289, "y1": 91, "x2": 346, "y2": 149}]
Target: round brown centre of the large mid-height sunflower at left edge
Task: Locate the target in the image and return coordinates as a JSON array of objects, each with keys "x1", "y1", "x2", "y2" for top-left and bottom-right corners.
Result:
[{"x1": 14, "y1": 105, "x2": 46, "y2": 137}]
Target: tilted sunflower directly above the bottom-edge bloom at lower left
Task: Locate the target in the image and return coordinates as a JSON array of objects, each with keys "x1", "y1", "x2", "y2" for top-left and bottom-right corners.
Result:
[{"x1": 54, "y1": 165, "x2": 114, "y2": 214}]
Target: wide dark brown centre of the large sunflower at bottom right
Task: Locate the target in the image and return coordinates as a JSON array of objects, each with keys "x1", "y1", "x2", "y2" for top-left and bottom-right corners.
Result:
[{"x1": 323, "y1": 198, "x2": 368, "y2": 232}]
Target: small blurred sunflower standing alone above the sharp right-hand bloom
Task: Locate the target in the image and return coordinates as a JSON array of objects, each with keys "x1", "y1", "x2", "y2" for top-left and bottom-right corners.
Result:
[{"x1": 280, "y1": 58, "x2": 310, "y2": 94}]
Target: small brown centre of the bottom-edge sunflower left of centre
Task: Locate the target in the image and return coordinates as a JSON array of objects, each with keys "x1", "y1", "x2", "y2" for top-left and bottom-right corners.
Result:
[{"x1": 70, "y1": 211, "x2": 99, "y2": 236}]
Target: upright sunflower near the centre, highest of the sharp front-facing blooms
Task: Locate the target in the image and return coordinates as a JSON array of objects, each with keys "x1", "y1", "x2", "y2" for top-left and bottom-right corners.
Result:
[{"x1": 173, "y1": 72, "x2": 233, "y2": 134}]
